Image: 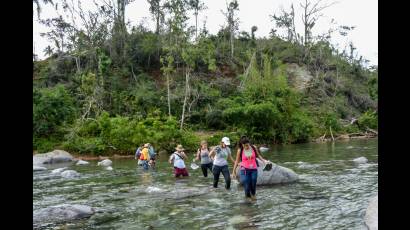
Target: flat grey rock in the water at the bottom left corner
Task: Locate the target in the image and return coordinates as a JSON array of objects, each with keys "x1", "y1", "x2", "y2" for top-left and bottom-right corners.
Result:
[{"x1": 33, "y1": 204, "x2": 95, "y2": 225}]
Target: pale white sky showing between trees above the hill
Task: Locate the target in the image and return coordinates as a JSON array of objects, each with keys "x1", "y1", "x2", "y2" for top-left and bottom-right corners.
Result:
[{"x1": 33, "y1": 0, "x2": 378, "y2": 65}]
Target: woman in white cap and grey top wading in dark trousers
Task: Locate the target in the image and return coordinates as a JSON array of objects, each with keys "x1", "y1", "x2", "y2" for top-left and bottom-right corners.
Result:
[{"x1": 209, "y1": 137, "x2": 235, "y2": 189}]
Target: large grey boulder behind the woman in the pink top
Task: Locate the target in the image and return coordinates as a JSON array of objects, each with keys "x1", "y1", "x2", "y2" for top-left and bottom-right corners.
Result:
[{"x1": 236, "y1": 159, "x2": 299, "y2": 185}]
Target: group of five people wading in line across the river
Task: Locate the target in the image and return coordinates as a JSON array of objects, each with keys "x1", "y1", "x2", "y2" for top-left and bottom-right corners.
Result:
[{"x1": 137, "y1": 136, "x2": 269, "y2": 200}]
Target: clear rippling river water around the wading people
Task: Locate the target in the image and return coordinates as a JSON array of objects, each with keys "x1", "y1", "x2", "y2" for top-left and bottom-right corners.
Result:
[{"x1": 33, "y1": 139, "x2": 378, "y2": 229}]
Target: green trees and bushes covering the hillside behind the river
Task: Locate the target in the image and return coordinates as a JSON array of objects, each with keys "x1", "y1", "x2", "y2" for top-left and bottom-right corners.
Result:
[{"x1": 33, "y1": 0, "x2": 378, "y2": 154}]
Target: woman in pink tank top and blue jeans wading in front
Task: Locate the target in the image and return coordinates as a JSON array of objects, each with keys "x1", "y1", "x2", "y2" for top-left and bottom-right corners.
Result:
[{"x1": 232, "y1": 137, "x2": 268, "y2": 200}]
